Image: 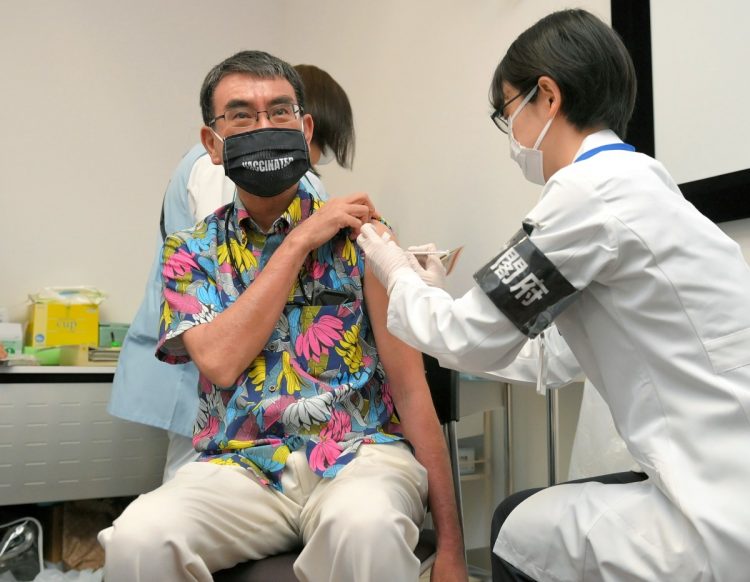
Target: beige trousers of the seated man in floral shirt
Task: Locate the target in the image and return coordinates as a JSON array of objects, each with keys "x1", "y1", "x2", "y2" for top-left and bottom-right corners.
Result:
[{"x1": 99, "y1": 443, "x2": 427, "y2": 582}]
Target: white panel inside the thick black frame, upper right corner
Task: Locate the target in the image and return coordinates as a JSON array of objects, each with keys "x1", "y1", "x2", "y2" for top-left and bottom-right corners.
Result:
[{"x1": 651, "y1": 0, "x2": 750, "y2": 184}]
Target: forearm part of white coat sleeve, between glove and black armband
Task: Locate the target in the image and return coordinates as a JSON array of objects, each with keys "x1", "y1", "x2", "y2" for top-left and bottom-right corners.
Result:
[{"x1": 388, "y1": 270, "x2": 527, "y2": 370}]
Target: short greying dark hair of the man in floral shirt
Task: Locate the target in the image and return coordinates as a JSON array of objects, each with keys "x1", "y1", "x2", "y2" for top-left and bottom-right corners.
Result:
[{"x1": 200, "y1": 51, "x2": 305, "y2": 125}]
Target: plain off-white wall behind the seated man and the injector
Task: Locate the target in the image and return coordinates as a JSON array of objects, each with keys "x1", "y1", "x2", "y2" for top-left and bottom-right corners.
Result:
[{"x1": 0, "y1": 0, "x2": 609, "y2": 321}]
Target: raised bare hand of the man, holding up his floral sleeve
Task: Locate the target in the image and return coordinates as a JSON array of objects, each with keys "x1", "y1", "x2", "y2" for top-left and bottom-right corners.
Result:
[{"x1": 287, "y1": 192, "x2": 380, "y2": 250}]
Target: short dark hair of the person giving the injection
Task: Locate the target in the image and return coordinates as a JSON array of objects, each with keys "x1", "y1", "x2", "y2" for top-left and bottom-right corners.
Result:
[{"x1": 490, "y1": 10, "x2": 636, "y2": 139}]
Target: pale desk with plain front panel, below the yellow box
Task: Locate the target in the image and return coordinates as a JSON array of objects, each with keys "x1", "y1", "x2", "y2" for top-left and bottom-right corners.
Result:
[{"x1": 0, "y1": 367, "x2": 167, "y2": 505}]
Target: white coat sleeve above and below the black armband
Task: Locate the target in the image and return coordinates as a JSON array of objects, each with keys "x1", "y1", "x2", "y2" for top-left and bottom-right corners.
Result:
[{"x1": 388, "y1": 164, "x2": 617, "y2": 380}]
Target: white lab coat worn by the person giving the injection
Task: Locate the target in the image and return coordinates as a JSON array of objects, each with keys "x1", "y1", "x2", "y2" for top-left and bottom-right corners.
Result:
[{"x1": 388, "y1": 131, "x2": 750, "y2": 582}]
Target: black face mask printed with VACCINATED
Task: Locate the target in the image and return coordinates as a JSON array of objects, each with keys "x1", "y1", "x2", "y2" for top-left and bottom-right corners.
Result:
[{"x1": 224, "y1": 127, "x2": 310, "y2": 198}]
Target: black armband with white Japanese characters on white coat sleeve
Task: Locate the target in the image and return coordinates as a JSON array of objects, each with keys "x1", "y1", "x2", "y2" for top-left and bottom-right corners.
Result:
[{"x1": 474, "y1": 230, "x2": 578, "y2": 338}]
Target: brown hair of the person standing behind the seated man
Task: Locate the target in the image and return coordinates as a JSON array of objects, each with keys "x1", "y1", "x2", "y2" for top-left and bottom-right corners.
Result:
[{"x1": 294, "y1": 65, "x2": 354, "y2": 168}]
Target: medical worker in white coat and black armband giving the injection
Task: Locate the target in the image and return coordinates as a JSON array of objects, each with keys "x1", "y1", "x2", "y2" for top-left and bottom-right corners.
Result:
[{"x1": 359, "y1": 10, "x2": 750, "y2": 582}]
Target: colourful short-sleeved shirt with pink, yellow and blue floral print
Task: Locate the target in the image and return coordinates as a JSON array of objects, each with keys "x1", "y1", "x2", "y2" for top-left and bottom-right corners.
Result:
[{"x1": 157, "y1": 186, "x2": 403, "y2": 489}]
